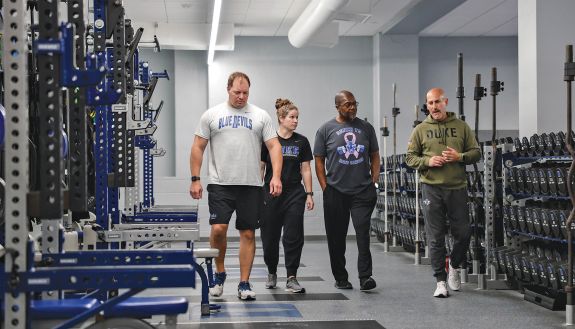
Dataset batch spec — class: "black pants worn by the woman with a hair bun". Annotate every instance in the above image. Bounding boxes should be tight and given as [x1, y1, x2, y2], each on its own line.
[260, 184, 307, 278]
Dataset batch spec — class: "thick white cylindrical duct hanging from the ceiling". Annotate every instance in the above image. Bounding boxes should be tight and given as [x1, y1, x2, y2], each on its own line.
[288, 0, 349, 48]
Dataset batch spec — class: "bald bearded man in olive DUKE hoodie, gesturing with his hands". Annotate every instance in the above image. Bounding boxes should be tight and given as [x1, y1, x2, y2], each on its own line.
[406, 88, 481, 297]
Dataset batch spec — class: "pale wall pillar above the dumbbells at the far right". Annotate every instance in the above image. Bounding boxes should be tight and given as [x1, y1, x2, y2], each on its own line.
[518, 0, 575, 136]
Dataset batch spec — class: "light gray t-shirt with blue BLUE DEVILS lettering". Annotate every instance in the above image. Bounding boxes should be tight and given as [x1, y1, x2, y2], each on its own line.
[195, 102, 277, 186]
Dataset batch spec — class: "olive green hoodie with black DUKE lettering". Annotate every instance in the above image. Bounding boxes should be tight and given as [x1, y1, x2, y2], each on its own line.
[406, 112, 481, 189]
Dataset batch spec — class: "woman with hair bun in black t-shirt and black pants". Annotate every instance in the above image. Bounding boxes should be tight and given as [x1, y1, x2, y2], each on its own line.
[261, 98, 314, 293]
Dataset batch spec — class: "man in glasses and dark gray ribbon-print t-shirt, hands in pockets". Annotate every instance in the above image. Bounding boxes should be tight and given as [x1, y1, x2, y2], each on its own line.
[313, 90, 380, 291]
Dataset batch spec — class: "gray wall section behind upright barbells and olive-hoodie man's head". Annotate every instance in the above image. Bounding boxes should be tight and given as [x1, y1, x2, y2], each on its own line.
[419, 37, 519, 137]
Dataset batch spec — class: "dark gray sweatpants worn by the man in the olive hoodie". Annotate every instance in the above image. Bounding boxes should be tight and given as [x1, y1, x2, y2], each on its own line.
[421, 184, 471, 282]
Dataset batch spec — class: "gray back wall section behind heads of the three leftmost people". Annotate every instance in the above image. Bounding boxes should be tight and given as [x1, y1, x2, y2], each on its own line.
[209, 37, 373, 145]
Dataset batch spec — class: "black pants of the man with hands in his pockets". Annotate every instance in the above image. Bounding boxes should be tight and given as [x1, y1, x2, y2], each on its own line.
[323, 185, 377, 281]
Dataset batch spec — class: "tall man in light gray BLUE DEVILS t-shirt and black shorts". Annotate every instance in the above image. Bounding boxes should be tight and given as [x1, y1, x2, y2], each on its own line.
[190, 72, 282, 300]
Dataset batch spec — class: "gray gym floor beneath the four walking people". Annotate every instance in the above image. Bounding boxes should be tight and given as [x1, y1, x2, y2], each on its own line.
[145, 239, 565, 329]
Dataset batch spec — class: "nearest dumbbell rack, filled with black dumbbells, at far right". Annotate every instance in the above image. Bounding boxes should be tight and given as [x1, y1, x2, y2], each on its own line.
[500, 132, 571, 310]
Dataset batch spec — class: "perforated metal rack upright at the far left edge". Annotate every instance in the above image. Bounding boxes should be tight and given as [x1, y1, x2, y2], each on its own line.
[2, 0, 29, 329]
